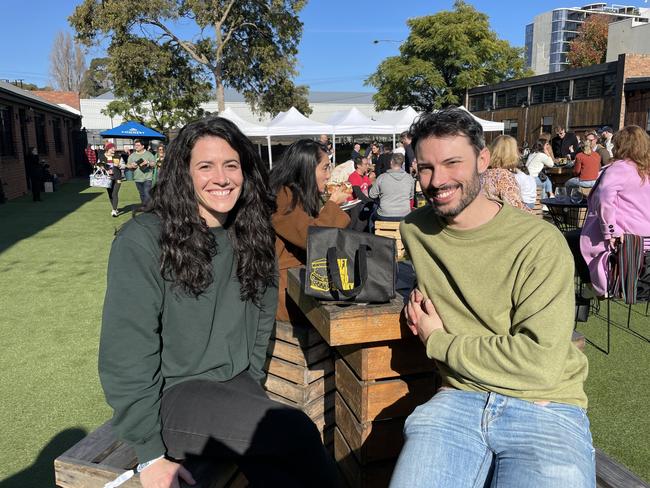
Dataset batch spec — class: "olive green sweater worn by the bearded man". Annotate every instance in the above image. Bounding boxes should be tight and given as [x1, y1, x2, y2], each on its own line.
[400, 205, 587, 408]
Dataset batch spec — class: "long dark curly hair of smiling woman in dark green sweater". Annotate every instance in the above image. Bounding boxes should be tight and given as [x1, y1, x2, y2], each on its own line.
[143, 117, 276, 303]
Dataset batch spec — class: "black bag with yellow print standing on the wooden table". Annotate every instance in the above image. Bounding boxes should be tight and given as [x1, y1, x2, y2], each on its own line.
[304, 226, 396, 303]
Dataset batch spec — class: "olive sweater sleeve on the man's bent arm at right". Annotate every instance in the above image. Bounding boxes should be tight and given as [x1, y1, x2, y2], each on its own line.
[426, 235, 574, 391]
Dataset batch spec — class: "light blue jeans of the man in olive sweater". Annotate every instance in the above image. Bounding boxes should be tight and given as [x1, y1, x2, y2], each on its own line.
[390, 389, 596, 488]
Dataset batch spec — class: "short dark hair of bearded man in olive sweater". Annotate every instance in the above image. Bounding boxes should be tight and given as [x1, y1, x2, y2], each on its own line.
[409, 107, 485, 156]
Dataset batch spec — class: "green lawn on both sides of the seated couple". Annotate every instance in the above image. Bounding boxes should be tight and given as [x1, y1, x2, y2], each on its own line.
[0, 181, 650, 488]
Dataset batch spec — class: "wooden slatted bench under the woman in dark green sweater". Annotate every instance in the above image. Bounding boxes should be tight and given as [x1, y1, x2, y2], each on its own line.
[54, 421, 247, 488]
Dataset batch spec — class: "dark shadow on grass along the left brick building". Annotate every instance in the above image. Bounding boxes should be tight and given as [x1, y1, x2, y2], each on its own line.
[0, 180, 100, 254]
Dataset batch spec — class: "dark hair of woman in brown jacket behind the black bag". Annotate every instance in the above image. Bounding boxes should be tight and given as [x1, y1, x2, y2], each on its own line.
[270, 139, 327, 217]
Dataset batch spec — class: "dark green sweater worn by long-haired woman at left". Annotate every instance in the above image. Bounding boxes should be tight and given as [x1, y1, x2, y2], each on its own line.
[99, 214, 278, 462]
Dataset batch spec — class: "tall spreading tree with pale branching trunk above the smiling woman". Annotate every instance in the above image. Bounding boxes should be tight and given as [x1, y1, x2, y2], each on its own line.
[69, 0, 306, 114]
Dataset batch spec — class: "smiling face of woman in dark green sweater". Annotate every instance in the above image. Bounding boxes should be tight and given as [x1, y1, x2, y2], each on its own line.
[190, 136, 244, 227]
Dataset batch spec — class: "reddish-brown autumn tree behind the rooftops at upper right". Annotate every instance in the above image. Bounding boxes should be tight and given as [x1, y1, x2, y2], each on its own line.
[566, 14, 609, 68]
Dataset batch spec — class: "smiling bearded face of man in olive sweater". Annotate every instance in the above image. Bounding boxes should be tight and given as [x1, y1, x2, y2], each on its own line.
[416, 135, 490, 219]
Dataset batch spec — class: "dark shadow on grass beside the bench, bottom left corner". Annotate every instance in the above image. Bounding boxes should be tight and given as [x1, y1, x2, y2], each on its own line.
[0, 428, 87, 488]
